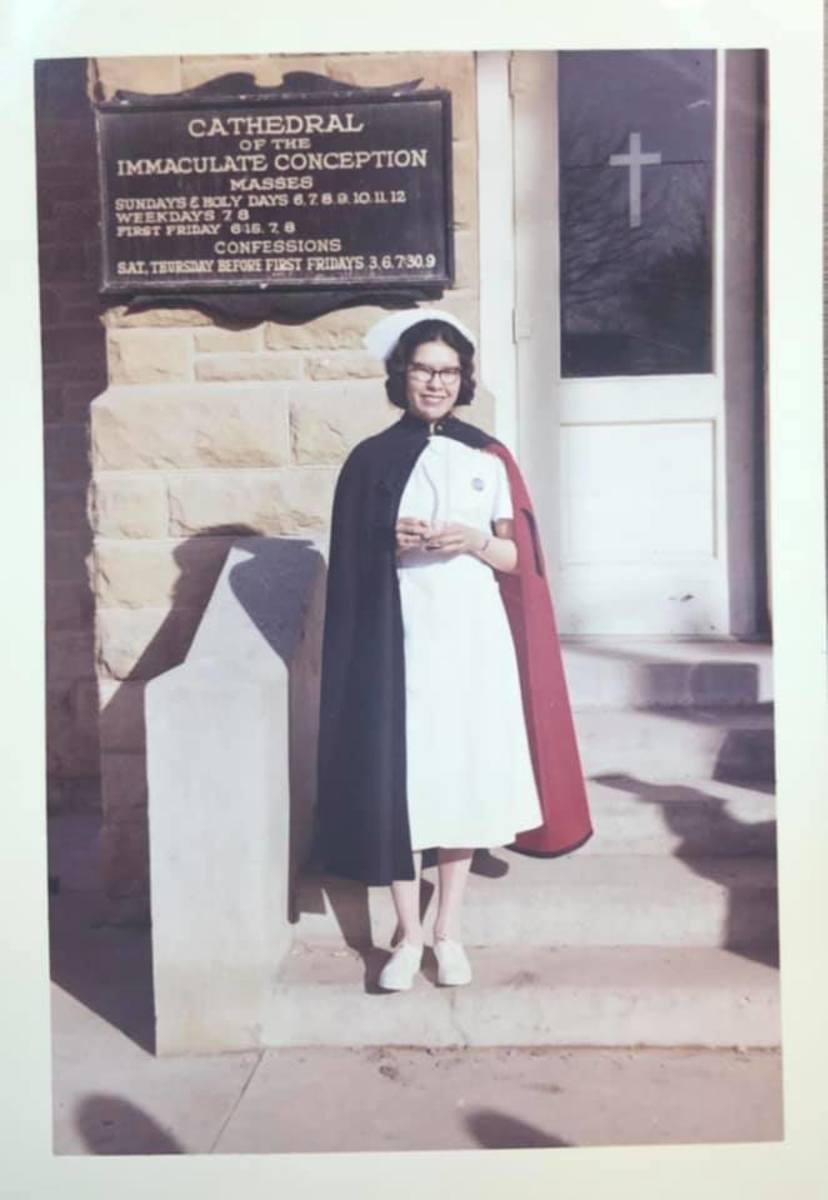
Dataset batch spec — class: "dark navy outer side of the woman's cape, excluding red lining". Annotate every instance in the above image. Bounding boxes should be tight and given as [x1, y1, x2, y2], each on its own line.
[317, 413, 589, 884]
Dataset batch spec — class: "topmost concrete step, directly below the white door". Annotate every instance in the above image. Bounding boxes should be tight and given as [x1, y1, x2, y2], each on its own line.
[562, 637, 773, 708]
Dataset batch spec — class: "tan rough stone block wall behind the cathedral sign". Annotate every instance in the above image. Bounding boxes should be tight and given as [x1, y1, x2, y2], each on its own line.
[88, 53, 484, 920]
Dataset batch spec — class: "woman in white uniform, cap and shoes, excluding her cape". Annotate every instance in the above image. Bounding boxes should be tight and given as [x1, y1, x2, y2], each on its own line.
[366, 310, 542, 991]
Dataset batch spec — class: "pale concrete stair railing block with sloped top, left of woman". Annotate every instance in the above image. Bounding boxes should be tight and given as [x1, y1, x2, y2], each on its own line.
[146, 538, 325, 1054]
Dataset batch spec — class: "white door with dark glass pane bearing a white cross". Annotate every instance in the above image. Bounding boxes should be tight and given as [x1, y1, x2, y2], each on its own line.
[494, 52, 761, 637]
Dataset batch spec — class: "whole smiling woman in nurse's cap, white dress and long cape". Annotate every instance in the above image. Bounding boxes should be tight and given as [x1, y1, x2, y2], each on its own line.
[319, 310, 592, 990]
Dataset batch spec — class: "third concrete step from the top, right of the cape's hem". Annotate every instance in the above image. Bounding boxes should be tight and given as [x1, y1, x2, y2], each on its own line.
[578, 775, 776, 858]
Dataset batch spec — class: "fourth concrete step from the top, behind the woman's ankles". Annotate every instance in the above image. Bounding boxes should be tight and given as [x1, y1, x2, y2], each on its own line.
[296, 851, 778, 949]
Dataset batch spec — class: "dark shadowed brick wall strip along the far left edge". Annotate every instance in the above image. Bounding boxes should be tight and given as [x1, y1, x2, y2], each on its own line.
[38, 59, 107, 812]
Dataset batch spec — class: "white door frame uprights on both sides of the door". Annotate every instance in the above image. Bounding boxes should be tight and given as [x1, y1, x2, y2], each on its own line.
[476, 50, 766, 637]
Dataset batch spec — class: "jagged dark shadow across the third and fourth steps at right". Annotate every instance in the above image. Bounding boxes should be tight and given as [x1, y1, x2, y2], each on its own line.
[593, 774, 779, 966]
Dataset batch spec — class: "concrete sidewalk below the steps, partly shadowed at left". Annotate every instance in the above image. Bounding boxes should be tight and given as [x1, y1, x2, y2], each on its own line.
[50, 818, 782, 1154]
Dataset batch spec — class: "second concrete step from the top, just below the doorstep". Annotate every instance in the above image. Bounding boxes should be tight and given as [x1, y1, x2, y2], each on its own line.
[574, 706, 774, 784]
